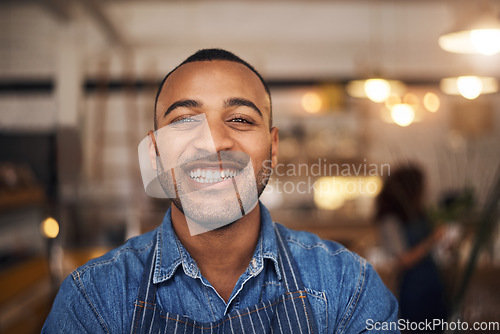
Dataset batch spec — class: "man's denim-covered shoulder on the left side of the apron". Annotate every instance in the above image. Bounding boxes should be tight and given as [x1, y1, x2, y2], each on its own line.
[46, 230, 156, 333]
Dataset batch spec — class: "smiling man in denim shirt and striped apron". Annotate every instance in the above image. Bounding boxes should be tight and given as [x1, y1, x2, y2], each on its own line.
[43, 49, 397, 333]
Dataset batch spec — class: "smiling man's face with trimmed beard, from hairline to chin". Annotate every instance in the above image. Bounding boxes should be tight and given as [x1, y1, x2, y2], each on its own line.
[156, 61, 278, 232]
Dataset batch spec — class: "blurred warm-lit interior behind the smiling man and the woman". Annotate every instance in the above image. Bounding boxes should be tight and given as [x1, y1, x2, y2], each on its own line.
[0, 0, 500, 333]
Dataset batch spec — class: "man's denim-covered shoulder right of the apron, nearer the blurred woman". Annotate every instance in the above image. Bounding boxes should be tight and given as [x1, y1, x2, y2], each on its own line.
[277, 224, 397, 333]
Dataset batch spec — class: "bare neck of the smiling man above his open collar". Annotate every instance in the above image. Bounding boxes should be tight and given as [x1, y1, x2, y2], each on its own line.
[171, 205, 260, 302]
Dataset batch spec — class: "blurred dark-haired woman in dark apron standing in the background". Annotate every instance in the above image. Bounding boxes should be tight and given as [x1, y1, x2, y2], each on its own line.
[375, 165, 447, 328]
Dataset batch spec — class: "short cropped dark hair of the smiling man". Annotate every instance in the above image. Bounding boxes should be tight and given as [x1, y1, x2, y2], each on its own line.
[153, 49, 273, 130]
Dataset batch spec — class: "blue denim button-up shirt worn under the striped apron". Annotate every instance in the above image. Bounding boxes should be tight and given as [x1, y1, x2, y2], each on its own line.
[42, 204, 398, 333]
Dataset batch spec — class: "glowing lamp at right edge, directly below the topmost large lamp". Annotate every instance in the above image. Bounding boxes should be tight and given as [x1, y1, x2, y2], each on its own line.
[440, 75, 498, 100]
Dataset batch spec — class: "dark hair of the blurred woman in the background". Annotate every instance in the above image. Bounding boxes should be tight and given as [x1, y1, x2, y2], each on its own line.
[375, 165, 424, 223]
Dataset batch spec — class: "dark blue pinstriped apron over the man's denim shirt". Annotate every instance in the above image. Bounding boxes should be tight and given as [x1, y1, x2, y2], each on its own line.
[130, 225, 318, 334]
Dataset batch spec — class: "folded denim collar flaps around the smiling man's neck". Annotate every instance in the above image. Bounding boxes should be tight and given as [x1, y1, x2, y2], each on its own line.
[153, 202, 281, 284]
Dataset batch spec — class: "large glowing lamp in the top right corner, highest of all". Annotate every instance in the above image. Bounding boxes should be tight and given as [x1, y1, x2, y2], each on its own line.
[439, 9, 500, 55]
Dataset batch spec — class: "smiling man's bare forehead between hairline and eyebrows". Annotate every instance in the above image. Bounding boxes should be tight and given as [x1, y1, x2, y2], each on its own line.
[158, 60, 270, 110]
